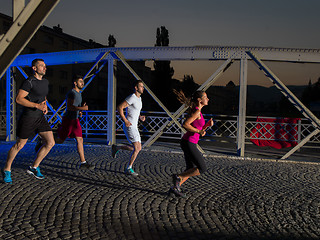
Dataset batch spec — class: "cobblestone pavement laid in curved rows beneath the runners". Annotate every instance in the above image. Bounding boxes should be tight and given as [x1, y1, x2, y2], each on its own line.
[0, 143, 320, 240]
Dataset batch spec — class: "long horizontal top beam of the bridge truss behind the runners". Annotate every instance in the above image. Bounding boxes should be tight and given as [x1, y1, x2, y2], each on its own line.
[12, 47, 320, 67]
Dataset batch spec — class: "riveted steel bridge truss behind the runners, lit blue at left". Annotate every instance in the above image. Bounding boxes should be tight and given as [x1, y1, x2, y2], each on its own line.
[7, 47, 320, 159]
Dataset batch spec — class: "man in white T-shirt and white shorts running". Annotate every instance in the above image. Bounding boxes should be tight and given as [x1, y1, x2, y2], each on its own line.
[112, 80, 145, 176]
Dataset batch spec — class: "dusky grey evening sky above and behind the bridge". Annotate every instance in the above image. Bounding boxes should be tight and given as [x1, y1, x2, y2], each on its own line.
[0, 0, 320, 85]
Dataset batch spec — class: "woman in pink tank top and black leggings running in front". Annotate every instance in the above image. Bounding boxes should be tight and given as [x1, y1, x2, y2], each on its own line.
[169, 91, 213, 197]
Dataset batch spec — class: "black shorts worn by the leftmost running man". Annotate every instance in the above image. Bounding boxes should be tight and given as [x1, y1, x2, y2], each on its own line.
[17, 115, 52, 139]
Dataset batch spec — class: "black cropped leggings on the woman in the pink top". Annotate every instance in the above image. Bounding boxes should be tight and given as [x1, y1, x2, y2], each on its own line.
[180, 139, 207, 173]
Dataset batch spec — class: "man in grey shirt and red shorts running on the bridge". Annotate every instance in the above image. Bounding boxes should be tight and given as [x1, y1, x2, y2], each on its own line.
[55, 75, 94, 170]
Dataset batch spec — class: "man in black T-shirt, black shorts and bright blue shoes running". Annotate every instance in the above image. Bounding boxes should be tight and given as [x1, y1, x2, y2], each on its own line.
[2, 59, 55, 183]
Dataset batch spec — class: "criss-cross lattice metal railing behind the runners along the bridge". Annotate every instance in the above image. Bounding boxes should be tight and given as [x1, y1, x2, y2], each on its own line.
[0, 111, 320, 145]
